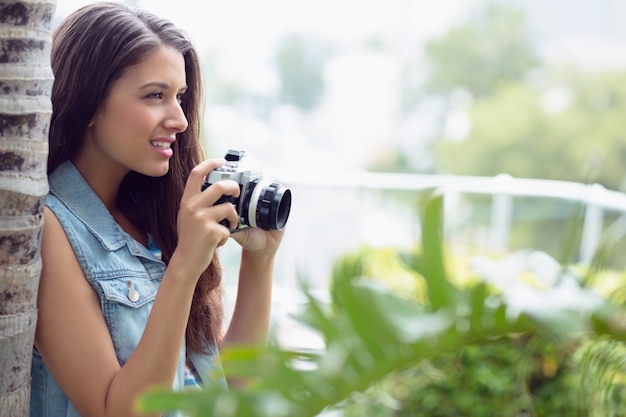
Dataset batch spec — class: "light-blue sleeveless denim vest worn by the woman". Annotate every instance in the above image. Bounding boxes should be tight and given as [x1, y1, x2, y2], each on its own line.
[30, 161, 226, 417]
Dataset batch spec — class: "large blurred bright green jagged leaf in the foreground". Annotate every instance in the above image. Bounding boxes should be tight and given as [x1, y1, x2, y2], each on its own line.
[137, 197, 625, 417]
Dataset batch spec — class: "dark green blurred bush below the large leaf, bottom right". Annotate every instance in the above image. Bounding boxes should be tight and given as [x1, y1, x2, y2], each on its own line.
[344, 336, 587, 417]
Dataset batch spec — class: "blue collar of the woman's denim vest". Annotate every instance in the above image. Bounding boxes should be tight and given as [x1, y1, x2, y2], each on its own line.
[48, 161, 130, 251]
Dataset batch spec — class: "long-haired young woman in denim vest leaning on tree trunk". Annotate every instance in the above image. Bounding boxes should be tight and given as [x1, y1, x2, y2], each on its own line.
[31, 3, 283, 417]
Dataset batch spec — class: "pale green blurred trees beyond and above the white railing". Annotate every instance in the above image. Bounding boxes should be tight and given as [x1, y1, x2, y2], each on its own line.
[394, 0, 626, 190]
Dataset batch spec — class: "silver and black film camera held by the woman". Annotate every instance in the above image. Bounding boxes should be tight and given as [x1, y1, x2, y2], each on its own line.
[202, 149, 291, 232]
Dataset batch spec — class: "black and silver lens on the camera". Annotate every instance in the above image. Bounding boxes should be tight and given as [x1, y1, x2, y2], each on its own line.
[242, 180, 291, 230]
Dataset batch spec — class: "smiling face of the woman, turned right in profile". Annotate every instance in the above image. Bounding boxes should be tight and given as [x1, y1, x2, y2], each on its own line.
[75, 47, 187, 177]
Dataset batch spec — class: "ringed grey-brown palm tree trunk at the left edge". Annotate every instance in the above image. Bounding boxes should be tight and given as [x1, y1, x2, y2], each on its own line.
[0, 0, 56, 417]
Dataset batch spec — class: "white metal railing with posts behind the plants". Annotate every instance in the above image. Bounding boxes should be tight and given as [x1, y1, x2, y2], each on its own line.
[284, 172, 626, 262]
